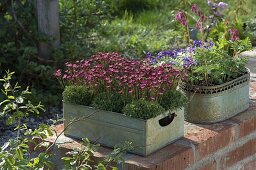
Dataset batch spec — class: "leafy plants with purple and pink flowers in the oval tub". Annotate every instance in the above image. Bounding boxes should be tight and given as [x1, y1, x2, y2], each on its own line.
[151, 0, 252, 86]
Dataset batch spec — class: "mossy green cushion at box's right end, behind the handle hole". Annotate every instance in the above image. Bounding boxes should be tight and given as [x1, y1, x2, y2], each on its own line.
[158, 90, 187, 110]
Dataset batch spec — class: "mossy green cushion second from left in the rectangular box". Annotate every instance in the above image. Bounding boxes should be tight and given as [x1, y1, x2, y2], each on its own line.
[92, 92, 125, 113]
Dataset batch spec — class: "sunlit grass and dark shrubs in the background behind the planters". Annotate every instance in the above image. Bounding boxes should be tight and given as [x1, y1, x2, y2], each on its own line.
[0, 0, 256, 111]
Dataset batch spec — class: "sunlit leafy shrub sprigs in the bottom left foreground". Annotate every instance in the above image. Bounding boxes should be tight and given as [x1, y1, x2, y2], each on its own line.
[0, 73, 133, 170]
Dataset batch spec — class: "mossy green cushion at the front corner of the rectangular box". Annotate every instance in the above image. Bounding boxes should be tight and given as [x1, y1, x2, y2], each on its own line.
[123, 99, 165, 120]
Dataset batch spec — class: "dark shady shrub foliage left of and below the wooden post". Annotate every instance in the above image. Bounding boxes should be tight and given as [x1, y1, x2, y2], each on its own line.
[0, 0, 63, 105]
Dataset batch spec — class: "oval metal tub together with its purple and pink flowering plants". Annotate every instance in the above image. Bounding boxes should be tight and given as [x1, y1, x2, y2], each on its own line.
[147, 0, 252, 123]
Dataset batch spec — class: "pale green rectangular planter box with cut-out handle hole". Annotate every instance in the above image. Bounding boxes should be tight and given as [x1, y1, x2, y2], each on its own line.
[63, 103, 184, 156]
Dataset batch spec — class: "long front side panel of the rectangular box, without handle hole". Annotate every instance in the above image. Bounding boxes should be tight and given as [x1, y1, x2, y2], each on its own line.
[63, 103, 146, 155]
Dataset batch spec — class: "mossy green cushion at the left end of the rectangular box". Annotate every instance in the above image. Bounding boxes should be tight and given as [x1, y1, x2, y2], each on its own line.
[63, 85, 93, 106]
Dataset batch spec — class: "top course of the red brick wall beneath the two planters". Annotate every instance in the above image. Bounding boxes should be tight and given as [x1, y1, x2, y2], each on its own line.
[48, 82, 256, 168]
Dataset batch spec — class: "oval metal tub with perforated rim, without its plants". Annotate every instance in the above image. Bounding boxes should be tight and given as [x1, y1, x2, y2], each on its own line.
[182, 71, 250, 124]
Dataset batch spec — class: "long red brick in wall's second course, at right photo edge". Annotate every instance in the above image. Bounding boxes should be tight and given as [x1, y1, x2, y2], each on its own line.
[221, 139, 256, 168]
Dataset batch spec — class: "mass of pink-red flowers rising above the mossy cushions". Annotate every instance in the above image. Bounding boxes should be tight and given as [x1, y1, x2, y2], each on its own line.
[55, 53, 185, 100]
